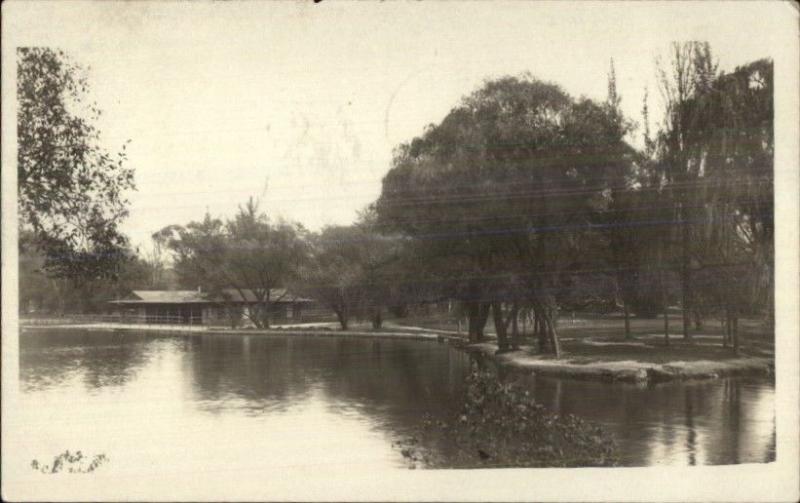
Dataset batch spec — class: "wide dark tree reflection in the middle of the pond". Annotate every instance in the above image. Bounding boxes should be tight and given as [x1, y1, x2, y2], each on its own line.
[184, 336, 468, 426]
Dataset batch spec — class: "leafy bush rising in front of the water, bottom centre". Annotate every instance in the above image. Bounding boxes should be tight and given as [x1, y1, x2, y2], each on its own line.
[400, 371, 616, 468]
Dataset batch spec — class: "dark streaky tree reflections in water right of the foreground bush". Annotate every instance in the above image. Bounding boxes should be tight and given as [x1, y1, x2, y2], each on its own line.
[510, 376, 774, 465]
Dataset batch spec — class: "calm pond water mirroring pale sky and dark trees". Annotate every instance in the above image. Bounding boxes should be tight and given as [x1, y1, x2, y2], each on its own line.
[14, 331, 775, 477]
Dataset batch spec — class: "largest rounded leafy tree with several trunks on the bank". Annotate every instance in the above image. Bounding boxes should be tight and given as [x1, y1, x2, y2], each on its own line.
[377, 76, 631, 354]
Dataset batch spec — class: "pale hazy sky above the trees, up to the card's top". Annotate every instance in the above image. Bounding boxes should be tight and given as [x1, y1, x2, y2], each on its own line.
[6, 1, 789, 252]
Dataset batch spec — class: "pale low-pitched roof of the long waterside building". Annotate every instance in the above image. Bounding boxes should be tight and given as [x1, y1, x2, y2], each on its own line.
[111, 288, 311, 304]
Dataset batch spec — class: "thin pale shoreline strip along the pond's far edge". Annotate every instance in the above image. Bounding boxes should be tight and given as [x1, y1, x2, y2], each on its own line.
[20, 324, 775, 384]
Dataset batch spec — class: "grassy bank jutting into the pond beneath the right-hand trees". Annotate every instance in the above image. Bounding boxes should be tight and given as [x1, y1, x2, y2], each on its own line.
[456, 316, 774, 382]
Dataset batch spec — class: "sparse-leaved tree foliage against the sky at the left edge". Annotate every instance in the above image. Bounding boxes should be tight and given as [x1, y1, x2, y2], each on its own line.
[17, 47, 134, 281]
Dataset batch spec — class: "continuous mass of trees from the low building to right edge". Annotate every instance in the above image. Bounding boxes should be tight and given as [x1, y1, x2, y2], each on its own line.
[17, 42, 774, 355]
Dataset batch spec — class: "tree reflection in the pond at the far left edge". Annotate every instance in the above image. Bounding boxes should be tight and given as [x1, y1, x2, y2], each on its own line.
[19, 330, 152, 391]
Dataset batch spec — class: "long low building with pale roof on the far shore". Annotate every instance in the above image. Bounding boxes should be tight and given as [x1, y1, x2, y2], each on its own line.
[110, 288, 314, 325]
